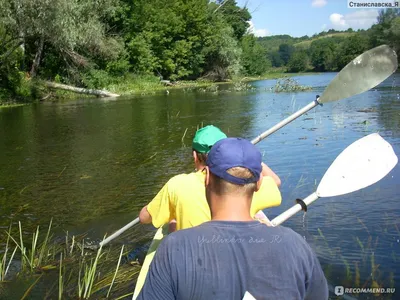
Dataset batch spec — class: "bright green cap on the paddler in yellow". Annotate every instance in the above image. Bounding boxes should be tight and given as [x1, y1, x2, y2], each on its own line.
[192, 125, 227, 153]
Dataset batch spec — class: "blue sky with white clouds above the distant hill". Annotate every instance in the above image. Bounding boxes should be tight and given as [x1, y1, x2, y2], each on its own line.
[236, 0, 391, 37]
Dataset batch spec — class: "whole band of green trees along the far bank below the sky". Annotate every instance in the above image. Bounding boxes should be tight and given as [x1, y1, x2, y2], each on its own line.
[0, 0, 400, 101]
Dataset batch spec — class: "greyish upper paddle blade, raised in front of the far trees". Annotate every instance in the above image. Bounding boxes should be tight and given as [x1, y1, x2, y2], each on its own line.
[318, 45, 398, 103]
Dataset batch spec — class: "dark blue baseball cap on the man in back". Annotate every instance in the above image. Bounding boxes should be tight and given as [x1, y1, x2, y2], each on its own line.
[206, 138, 262, 185]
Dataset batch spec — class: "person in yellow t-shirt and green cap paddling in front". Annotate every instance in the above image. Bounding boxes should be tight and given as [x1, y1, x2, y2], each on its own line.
[139, 125, 282, 231]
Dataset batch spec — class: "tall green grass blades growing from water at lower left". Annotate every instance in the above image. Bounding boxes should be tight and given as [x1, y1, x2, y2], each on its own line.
[0, 219, 147, 299]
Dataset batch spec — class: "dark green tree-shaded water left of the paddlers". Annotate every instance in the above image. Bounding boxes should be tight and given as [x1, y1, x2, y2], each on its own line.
[0, 92, 254, 232]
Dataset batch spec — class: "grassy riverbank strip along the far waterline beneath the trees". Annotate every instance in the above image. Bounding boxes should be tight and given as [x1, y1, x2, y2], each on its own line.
[0, 70, 317, 108]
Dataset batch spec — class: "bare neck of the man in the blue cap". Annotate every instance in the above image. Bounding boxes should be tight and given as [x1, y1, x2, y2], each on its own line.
[210, 196, 254, 222]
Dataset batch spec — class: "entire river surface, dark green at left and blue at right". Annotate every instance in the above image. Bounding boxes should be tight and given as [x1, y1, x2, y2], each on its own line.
[0, 73, 400, 299]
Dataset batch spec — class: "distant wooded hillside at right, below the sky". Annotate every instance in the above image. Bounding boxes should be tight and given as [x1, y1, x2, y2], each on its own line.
[259, 9, 400, 72]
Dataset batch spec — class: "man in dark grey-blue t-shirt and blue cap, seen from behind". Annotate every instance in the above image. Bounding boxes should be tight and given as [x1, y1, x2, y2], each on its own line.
[138, 138, 328, 300]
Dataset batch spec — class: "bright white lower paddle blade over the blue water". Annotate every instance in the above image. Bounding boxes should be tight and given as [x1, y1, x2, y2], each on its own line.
[317, 133, 398, 197]
